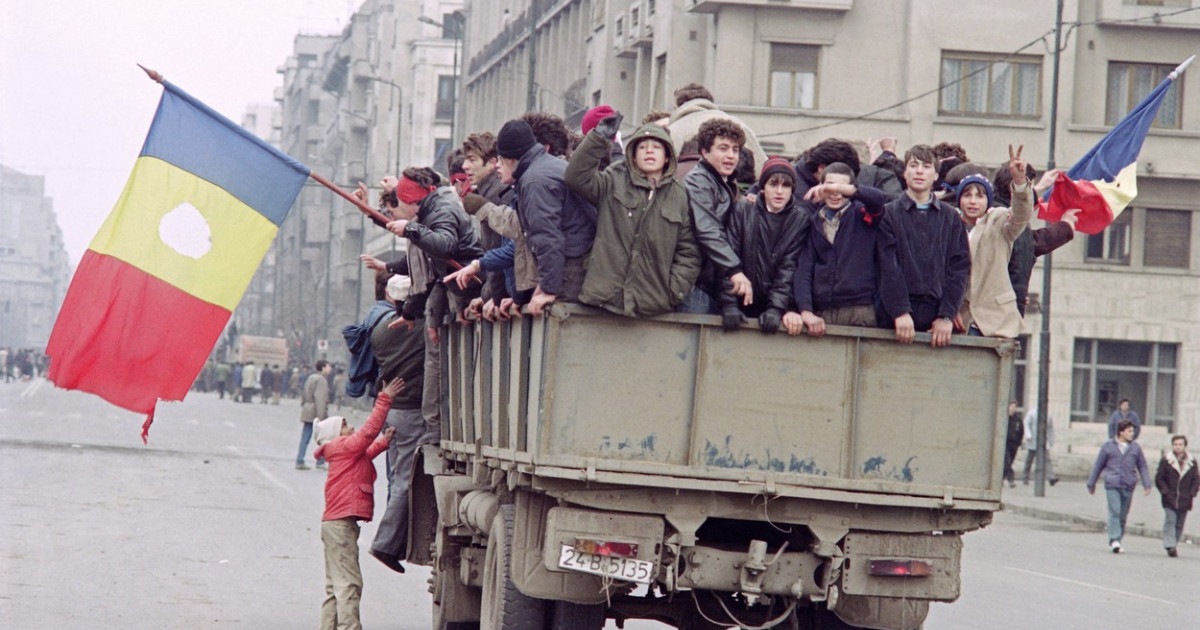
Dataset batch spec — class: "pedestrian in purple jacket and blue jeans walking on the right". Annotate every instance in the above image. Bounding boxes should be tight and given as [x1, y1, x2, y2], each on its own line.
[1087, 420, 1150, 553]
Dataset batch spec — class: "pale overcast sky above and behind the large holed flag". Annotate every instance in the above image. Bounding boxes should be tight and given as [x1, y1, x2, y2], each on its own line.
[0, 0, 359, 264]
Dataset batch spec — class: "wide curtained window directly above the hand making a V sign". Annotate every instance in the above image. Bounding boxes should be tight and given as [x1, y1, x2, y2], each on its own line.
[938, 53, 1042, 118]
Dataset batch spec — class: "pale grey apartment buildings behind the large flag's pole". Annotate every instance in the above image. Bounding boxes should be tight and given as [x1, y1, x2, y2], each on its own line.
[232, 0, 462, 362]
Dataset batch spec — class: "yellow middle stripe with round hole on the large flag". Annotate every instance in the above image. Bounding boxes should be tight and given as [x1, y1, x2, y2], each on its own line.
[89, 157, 278, 311]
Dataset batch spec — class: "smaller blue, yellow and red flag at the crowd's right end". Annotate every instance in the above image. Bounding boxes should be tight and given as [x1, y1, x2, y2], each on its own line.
[1038, 59, 1192, 235]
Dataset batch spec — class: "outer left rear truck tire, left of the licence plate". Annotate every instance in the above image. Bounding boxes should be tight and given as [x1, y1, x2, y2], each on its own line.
[479, 504, 546, 630]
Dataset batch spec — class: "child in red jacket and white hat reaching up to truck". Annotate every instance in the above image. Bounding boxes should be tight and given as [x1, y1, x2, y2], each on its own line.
[314, 378, 404, 630]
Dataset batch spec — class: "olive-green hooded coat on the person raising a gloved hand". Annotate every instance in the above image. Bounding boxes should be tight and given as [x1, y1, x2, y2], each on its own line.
[565, 124, 701, 317]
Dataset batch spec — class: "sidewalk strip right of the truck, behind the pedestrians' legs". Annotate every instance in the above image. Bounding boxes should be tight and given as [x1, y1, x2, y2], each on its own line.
[1002, 472, 1200, 545]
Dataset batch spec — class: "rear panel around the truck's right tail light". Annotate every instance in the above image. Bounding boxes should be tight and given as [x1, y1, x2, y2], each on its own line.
[841, 532, 962, 601]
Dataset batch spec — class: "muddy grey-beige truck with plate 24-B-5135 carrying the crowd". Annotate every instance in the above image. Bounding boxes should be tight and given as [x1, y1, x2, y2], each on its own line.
[408, 305, 1016, 630]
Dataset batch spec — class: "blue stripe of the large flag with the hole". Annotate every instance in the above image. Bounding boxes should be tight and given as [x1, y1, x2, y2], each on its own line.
[142, 82, 308, 226]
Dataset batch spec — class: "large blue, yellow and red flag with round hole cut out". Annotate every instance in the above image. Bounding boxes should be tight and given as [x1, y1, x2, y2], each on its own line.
[46, 80, 308, 440]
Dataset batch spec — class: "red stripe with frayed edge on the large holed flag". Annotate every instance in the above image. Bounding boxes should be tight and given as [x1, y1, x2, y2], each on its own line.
[46, 250, 230, 414]
